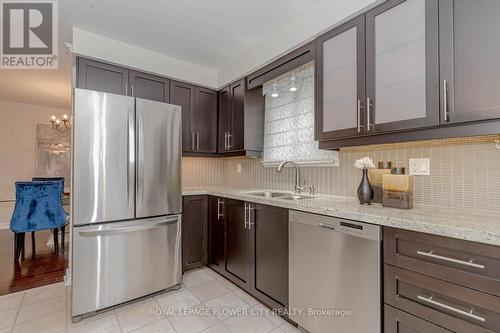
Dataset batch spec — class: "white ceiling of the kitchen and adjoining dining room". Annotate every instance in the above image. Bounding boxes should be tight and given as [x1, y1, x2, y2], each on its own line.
[0, 0, 322, 108]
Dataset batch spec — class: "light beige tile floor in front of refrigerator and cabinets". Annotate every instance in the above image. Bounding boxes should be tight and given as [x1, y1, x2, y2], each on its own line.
[0, 268, 299, 333]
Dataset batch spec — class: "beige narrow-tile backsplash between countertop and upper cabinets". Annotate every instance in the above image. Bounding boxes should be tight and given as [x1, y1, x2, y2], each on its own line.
[183, 136, 500, 211]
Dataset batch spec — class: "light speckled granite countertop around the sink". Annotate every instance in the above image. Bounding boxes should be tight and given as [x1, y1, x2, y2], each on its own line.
[182, 186, 500, 246]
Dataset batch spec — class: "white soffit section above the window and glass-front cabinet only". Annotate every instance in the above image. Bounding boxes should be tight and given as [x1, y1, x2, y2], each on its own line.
[218, 0, 381, 87]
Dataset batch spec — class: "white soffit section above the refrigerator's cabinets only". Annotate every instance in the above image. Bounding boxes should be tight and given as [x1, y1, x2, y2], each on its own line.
[73, 27, 218, 88]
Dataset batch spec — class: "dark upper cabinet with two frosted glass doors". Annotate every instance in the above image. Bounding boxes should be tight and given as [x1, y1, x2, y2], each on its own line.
[316, 0, 439, 141]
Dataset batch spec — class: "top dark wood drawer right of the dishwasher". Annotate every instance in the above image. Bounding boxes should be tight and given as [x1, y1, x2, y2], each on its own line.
[384, 228, 500, 296]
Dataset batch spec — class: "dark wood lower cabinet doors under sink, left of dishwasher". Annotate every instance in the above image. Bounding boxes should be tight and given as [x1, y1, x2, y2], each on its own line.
[208, 197, 288, 309]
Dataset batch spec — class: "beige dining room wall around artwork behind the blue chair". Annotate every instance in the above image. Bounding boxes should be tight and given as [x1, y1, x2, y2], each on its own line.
[0, 101, 70, 200]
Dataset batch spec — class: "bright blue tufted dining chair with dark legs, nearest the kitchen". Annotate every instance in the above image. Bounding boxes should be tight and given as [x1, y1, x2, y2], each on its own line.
[10, 181, 66, 261]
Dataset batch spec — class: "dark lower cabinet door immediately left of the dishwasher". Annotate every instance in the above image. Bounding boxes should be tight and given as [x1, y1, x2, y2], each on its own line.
[249, 204, 288, 308]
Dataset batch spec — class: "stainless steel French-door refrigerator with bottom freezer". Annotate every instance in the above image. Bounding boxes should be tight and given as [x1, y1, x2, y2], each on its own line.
[72, 89, 182, 321]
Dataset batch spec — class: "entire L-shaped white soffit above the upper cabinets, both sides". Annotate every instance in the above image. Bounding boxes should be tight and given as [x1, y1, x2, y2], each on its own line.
[73, 0, 383, 88]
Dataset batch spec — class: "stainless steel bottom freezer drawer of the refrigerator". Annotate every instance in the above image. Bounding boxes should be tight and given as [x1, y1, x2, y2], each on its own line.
[72, 215, 182, 317]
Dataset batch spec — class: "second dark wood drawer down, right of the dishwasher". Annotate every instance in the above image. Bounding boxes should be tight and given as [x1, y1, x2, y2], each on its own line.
[384, 264, 500, 333]
